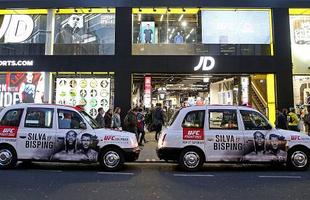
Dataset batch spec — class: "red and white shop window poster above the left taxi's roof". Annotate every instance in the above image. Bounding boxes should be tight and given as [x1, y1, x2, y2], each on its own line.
[0, 72, 44, 107]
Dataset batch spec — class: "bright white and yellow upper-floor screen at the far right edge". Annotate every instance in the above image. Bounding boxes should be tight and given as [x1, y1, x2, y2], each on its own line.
[290, 15, 310, 74]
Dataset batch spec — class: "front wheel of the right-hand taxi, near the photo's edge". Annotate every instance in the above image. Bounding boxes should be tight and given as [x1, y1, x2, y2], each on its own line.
[287, 148, 310, 171]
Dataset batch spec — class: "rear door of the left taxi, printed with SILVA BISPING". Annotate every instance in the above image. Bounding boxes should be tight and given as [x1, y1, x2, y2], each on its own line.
[17, 107, 56, 160]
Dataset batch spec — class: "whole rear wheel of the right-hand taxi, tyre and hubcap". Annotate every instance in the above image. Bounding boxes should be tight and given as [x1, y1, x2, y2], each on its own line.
[179, 148, 204, 171]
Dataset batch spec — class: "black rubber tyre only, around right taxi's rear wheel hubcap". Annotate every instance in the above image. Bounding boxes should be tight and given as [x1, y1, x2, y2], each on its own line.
[179, 147, 204, 172]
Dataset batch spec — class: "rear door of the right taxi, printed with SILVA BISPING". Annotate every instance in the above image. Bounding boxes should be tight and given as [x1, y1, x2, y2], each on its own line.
[205, 109, 244, 162]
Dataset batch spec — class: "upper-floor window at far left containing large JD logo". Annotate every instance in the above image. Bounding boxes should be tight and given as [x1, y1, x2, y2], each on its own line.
[0, 9, 47, 55]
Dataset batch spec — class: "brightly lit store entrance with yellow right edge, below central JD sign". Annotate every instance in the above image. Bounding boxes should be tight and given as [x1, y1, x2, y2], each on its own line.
[132, 73, 275, 122]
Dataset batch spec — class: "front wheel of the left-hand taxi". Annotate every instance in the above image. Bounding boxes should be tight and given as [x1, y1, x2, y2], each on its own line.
[99, 147, 125, 172]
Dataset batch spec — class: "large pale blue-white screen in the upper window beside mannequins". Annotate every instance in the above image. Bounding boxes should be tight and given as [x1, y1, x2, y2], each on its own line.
[201, 10, 271, 44]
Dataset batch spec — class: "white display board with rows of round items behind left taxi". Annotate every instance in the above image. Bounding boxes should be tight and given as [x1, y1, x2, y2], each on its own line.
[56, 78, 110, 117]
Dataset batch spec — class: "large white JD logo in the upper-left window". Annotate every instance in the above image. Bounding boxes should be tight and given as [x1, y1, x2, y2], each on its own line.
[0, 15, 33, 43]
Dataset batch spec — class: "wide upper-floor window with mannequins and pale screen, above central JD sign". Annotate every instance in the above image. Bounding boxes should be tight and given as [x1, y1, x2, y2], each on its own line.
[132, 8, 273, 55]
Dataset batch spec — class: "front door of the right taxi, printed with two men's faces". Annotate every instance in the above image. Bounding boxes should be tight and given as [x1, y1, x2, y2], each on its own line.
[240, 110, 287, 162]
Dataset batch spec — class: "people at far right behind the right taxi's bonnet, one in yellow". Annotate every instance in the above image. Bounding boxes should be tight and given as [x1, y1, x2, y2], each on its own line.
[275, 106, 310, 136]
